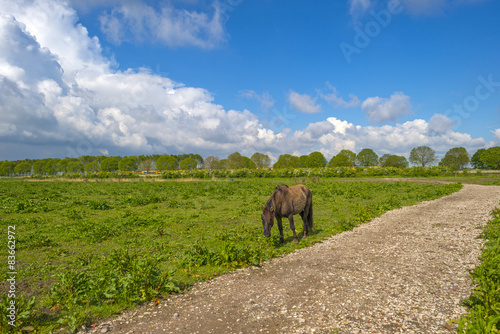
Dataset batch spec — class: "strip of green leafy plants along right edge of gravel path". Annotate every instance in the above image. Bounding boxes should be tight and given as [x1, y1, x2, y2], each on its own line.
[458, 206, 500, 333]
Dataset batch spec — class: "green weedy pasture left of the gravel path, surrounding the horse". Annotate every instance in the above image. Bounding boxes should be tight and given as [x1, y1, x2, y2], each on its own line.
[0, 178, 461, 333]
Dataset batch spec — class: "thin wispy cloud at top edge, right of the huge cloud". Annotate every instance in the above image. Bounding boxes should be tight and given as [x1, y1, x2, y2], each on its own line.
[100, 1, 227, 48]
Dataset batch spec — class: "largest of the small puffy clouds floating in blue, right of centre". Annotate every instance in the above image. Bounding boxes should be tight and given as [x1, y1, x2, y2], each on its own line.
[361, 92, 411, 124]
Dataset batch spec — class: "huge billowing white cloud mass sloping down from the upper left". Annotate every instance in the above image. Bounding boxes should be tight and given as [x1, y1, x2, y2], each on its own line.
[0, 1, 280, 156]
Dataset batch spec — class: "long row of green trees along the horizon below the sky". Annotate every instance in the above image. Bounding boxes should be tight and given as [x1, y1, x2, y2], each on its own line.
[0, 146, 500, 176]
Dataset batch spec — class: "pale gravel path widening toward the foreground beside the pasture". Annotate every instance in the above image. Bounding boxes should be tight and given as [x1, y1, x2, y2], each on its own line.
[84, 185, 500, 334]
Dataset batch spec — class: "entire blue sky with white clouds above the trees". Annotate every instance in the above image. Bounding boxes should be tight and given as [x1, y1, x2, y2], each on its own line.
[0, 0, 500, 160]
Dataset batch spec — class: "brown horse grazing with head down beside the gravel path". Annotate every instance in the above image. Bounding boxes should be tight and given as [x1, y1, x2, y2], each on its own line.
[261, 184, 314, 244]
